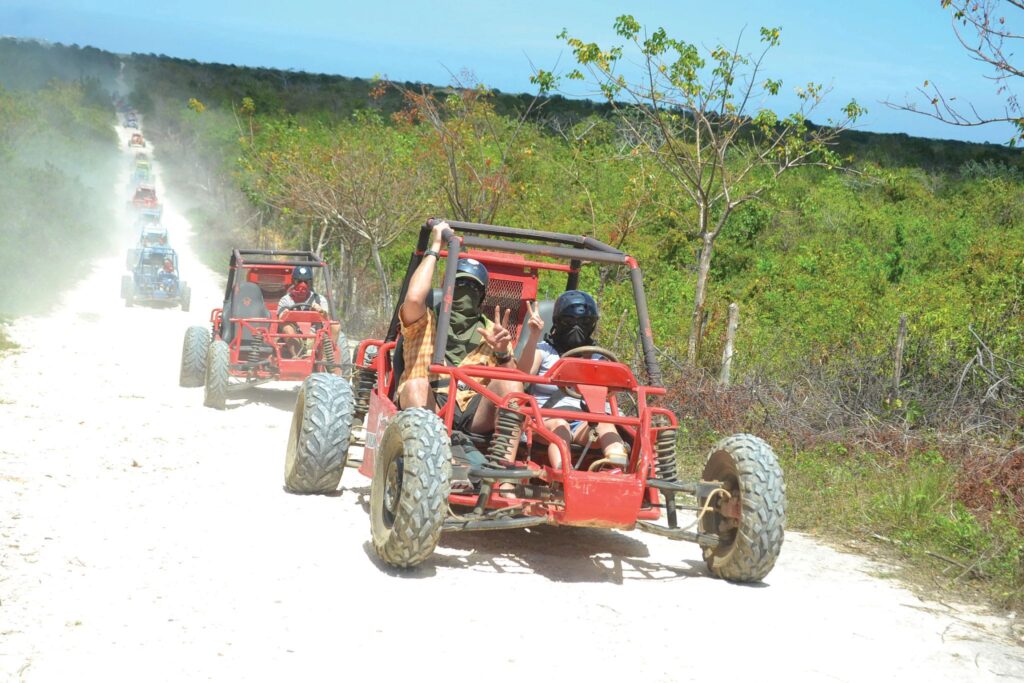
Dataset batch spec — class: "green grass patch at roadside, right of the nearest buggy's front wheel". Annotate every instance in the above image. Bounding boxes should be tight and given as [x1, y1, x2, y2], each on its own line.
[779, 444, 1024, 609]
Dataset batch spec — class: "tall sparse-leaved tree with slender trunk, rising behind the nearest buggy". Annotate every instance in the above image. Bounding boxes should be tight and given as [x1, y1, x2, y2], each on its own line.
[532, 15, 864, 365]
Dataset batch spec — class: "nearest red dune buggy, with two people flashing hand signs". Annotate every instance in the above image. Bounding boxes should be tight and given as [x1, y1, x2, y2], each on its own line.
[285, 221, 785, 582]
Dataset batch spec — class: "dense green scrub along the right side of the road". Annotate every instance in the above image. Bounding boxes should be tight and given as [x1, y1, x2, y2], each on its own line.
[4, 34, 1024, 604]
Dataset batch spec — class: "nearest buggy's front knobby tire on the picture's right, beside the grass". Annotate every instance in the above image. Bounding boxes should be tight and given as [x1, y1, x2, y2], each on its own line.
[699, 434, 785, 582]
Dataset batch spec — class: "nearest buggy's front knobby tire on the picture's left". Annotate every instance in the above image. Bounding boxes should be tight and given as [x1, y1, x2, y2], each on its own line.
[370, 408, 452, 568]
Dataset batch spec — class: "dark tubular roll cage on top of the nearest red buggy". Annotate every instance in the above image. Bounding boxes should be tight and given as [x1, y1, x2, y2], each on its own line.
[385, 218, 662, 387]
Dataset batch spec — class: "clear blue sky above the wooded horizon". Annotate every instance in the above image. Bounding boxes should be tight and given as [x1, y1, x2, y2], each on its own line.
[0, 0, 1024, 143]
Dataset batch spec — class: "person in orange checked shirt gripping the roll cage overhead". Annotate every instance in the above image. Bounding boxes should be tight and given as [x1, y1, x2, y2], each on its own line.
[398, 221, 522, 433]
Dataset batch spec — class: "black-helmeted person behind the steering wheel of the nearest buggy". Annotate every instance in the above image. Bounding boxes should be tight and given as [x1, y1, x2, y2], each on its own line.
[518, 290, 629, 469]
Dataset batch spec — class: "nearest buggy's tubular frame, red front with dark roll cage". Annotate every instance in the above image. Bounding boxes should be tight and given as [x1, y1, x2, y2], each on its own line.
[355, 221, 678, 528]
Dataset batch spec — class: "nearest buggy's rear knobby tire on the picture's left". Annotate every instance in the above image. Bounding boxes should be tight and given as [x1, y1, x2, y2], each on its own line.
[285, 373, 355, 494]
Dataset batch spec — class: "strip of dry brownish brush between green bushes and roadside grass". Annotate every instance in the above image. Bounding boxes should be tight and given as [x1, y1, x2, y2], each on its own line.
[647, 339, 1024, 529]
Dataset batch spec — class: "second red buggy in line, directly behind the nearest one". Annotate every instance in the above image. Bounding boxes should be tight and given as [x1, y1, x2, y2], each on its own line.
[179, 249, 344, 410]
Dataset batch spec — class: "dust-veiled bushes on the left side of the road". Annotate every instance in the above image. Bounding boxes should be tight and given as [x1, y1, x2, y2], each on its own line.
[0, 42, 117, 314]
